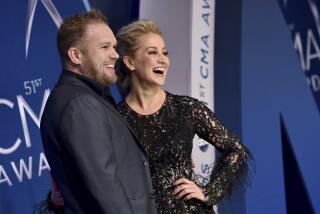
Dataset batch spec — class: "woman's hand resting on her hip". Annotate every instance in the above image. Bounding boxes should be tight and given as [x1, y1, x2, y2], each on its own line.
[173, 178, 208, 202]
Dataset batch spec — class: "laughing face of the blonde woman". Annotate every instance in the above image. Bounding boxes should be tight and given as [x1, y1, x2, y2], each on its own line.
[132, 33, 170, 86]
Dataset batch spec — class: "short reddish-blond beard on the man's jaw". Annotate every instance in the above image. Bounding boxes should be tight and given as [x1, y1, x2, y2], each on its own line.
[82, 59, 117, 85]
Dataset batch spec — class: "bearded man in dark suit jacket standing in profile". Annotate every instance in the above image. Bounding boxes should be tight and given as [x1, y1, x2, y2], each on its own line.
[41, 9, 156, 214]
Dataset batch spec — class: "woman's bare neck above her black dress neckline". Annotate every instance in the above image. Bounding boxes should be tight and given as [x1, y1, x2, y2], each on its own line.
[125, 85, 166, 115]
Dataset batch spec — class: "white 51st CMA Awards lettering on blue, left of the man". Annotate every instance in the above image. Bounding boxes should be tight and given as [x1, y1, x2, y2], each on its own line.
[0, 85, 50, 186]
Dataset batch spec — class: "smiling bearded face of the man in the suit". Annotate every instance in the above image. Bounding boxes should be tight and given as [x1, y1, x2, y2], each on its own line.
[80, 23, 119, 85]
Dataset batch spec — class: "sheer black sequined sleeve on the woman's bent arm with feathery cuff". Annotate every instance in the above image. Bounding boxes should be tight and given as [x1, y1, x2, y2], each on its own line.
[189, 99, 252, 205]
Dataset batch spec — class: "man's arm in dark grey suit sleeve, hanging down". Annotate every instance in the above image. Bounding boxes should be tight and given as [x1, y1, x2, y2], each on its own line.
[60, 95, 133, 214]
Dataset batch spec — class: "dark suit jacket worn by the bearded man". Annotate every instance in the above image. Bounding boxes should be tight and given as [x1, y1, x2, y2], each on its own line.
[40, 71, 156, 214]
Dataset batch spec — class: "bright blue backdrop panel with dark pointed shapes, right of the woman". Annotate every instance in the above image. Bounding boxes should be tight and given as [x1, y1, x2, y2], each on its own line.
[241, 0, 320, 214]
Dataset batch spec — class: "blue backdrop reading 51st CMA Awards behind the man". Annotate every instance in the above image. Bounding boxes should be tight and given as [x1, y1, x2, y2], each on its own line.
[0, 0, 139, 214]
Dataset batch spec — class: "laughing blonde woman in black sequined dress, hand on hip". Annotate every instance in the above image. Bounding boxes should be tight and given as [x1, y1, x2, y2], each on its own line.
[47, 20, 251, 213]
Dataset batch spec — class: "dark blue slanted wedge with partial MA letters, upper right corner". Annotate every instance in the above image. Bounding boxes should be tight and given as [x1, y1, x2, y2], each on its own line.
[278, 0, 320, 111]
